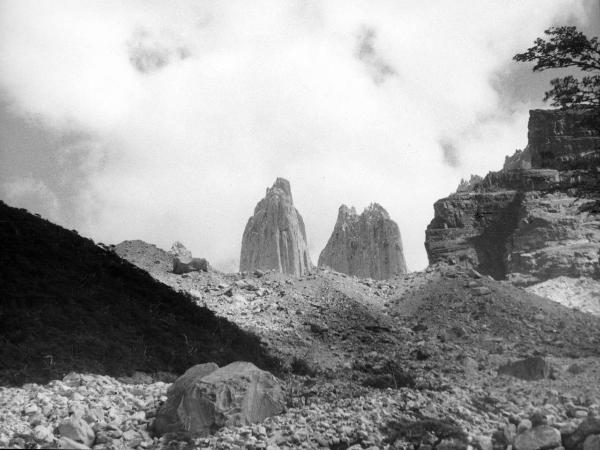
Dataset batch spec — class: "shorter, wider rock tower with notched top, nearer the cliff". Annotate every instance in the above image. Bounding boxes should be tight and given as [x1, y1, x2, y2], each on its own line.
[319, 203, 406, 279]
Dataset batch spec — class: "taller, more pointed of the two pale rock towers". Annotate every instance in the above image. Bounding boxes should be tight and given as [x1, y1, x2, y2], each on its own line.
[240, 178, 312, 276]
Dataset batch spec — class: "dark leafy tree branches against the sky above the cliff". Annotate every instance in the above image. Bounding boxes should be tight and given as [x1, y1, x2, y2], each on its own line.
[514, 27, 600, 109]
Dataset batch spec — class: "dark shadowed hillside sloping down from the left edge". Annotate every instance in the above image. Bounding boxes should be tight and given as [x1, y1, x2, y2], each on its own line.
[0, 201, 274, 384]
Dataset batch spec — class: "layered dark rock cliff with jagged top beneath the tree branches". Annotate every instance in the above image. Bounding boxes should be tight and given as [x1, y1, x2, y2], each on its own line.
[425, 110, 600, 285]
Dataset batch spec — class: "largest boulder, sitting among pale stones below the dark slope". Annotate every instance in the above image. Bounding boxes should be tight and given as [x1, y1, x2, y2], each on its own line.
[155, 362, 286, 436]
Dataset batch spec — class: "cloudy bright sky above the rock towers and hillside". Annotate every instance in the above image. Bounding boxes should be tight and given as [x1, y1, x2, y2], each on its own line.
[0, 0, 600, 271]
